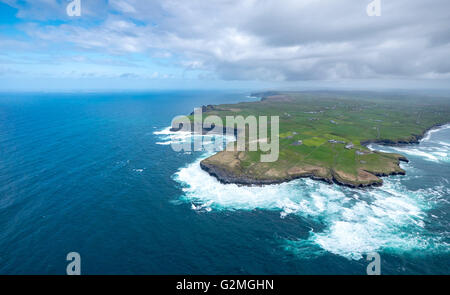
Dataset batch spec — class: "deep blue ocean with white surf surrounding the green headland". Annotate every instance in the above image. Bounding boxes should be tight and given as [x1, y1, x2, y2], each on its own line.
[0, 91, 450, 274]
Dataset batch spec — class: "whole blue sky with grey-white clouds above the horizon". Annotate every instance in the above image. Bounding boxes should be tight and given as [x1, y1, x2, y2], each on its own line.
[0, 0, 450, 91]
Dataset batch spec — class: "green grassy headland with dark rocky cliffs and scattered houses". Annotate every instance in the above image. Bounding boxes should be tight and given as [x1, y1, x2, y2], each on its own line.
[173, 91, 450, 188]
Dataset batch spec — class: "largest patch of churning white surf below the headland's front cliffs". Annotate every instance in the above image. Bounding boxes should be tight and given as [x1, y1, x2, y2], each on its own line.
[175, 154, 446, 259]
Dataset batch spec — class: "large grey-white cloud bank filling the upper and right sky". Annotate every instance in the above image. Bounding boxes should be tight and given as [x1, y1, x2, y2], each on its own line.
[0, 0, 450, 81]
